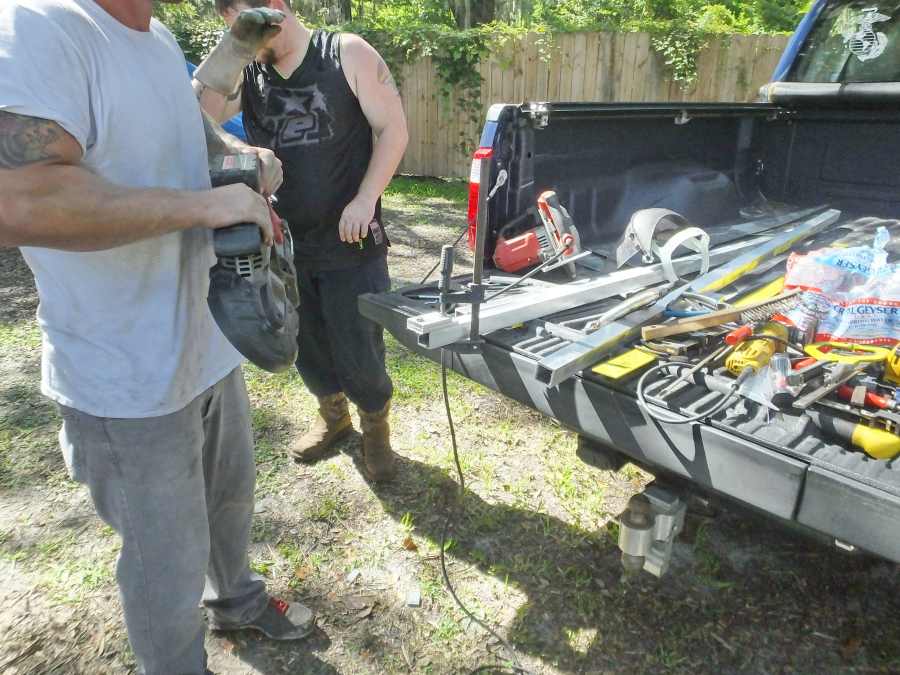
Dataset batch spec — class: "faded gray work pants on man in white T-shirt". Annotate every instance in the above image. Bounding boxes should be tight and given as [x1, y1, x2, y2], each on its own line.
[59, 368, 268, 675]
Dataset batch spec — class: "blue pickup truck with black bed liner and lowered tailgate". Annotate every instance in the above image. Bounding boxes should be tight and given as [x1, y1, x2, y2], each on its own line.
[359, 0, 900, 562]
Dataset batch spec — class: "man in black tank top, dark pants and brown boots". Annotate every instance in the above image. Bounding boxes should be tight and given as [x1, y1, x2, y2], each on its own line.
[195, 0, 407, 480]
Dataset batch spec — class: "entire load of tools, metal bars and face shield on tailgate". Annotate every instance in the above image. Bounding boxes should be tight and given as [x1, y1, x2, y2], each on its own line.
[420, 184, 900, 459]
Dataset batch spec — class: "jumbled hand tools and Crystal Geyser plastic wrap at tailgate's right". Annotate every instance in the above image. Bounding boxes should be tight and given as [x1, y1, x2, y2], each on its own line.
[628, 224, 900, 459]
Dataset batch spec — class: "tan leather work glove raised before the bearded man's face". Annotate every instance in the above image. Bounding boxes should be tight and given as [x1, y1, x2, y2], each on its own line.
[194, 7, 284, 97]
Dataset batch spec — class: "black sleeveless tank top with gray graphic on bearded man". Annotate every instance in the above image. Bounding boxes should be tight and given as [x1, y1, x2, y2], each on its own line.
[241, 30, 390, 270]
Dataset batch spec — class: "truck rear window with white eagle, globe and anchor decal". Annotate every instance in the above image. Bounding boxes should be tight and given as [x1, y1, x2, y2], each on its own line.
[788, 0, 900, 83]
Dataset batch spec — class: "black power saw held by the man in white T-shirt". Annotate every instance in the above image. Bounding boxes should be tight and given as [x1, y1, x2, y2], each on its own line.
[207, 154, 300, 372]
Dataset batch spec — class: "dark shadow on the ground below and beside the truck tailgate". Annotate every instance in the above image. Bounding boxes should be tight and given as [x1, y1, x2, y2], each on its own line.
[355, 456, 900, 673]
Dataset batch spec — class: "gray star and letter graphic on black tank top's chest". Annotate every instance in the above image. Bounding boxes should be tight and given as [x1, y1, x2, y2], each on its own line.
[257, 74, 334, 149]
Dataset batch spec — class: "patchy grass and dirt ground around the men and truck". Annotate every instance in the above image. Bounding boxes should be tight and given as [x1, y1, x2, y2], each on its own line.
[0, 185, 900, 675]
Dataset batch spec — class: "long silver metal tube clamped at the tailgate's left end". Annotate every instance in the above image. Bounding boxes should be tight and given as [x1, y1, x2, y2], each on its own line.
[406, 239, 772, 349]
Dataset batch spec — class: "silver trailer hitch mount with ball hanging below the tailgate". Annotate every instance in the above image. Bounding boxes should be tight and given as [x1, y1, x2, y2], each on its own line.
[619, 484, 687, 577]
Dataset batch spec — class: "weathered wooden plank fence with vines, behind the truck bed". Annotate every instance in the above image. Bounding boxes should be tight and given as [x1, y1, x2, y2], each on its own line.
[400, 33, 788, 178]
